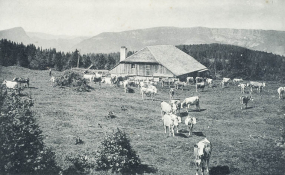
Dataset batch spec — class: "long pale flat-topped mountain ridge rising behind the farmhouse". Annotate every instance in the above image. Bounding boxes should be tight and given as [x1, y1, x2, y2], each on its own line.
[73, 27, 285, 55]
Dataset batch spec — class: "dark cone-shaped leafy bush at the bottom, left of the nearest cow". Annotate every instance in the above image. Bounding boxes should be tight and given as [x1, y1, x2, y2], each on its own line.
[96, 129, 141, 174]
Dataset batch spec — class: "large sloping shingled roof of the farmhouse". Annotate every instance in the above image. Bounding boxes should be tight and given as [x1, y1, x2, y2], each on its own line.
[118, 45, 207, 76]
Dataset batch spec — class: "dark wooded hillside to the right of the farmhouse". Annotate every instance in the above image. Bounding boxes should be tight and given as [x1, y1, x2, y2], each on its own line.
[177, 44, 285, 80]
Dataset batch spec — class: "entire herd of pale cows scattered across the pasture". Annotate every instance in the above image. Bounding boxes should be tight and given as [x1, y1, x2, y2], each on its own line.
[2, 74, 285, 174]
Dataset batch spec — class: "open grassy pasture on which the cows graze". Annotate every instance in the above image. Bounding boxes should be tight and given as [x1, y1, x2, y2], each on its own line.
[0, 66, 285, 175]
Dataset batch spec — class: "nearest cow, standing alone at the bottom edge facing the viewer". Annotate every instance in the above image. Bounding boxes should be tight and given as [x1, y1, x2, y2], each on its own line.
[194, 138, 212, 175]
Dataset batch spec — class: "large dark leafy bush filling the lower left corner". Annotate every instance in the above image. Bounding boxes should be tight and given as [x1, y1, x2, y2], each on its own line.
[0, 90, 60, 174]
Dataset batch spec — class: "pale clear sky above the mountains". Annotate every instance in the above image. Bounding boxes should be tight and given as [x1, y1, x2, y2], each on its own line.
[0, 0, 285, 36]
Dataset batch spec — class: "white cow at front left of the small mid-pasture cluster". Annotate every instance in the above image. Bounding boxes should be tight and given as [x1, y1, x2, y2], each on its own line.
[162, 114, 181, 137]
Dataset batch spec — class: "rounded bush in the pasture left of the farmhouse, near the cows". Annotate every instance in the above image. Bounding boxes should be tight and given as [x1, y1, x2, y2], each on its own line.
[55, 70, 91, 92]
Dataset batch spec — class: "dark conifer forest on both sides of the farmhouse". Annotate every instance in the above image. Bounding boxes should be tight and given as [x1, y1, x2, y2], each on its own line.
[0, 39, 285, 80]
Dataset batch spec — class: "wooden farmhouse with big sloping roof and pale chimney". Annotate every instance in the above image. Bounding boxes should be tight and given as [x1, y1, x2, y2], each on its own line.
[110, 45, 208, 80]
